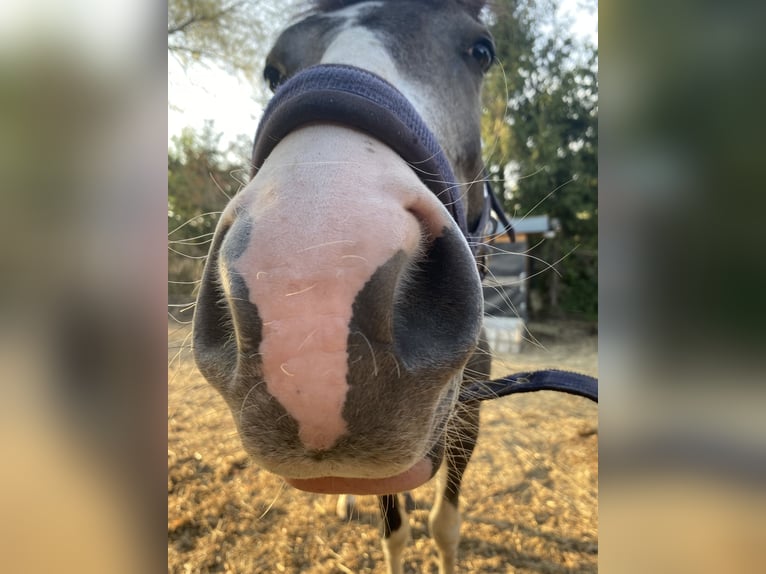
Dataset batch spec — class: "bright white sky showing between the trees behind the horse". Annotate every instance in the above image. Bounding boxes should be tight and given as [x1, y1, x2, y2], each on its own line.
[168, 0, 598, 151]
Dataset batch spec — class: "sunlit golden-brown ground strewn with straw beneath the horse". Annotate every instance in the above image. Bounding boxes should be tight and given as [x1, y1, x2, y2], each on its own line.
[168, 323, 598, 574]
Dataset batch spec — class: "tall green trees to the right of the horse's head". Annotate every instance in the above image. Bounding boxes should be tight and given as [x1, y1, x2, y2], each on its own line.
[482, 0, 598, 319]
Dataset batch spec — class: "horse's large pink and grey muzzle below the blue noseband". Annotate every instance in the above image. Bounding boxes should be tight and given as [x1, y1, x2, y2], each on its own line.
[194, 64, 482, 493]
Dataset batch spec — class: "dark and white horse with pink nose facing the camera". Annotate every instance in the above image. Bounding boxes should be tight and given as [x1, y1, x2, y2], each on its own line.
[193, 0, 524, 573]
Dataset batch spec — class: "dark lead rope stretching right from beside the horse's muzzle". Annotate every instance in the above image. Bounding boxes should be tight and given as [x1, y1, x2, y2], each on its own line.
[458, 369, 598, 403]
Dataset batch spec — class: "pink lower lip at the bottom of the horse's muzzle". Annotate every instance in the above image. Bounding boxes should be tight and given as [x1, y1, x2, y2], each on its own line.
[285, 458, 433, 495]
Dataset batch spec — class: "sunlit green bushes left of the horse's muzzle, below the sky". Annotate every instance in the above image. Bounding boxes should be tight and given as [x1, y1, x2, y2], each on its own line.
[168, 123, 248, 304]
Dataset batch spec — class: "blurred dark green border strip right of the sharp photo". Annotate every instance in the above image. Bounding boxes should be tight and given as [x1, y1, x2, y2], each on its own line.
[599, 1, 766, 572]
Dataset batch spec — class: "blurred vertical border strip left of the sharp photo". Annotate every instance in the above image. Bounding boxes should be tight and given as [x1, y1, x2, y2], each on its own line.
[0, 0, 167, 573]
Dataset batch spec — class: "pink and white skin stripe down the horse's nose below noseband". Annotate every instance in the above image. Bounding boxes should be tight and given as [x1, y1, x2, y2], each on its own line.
[232, 126, 451, 454]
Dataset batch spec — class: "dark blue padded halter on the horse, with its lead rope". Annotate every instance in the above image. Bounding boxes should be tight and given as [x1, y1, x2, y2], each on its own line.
[251, 64, 598, 403]
